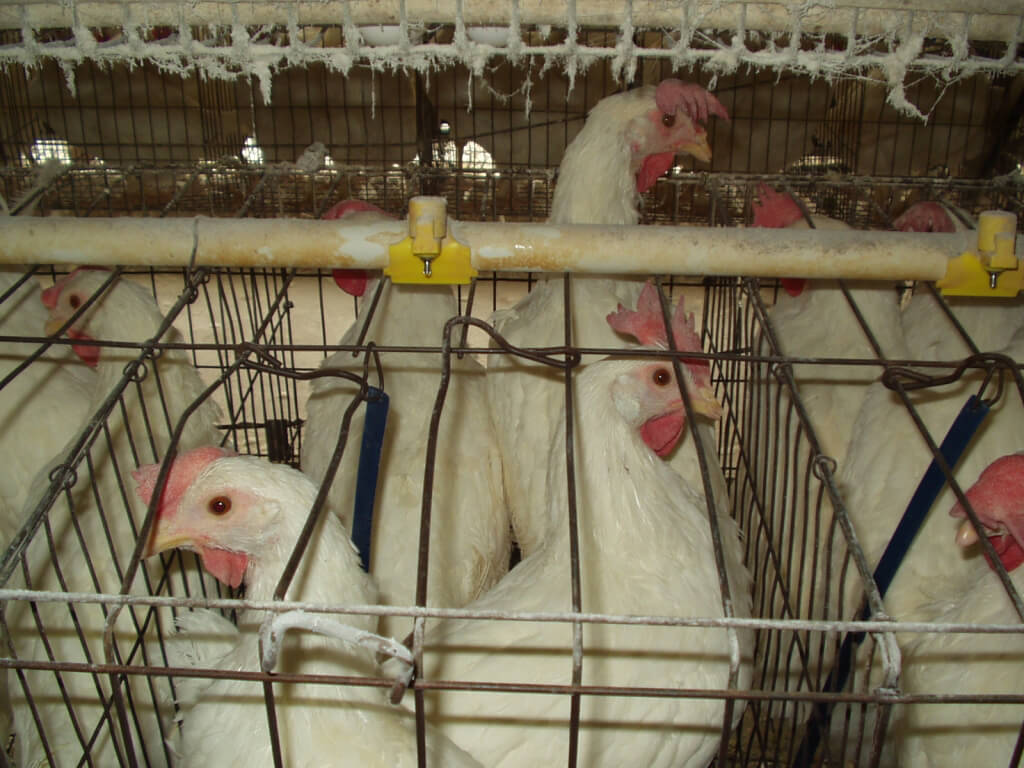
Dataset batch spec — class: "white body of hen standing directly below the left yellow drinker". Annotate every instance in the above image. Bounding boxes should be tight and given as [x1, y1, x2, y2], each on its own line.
[302, 274, 511, 637]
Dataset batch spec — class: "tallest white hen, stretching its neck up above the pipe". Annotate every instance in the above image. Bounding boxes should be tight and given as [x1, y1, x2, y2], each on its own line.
[487, 79, 727, 555]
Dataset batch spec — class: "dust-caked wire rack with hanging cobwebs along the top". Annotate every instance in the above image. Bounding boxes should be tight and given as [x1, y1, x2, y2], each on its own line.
[0, 0, 1024, 119]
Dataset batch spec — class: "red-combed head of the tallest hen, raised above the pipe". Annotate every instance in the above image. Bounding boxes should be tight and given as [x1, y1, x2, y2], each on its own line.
[630, 78, 729, 194]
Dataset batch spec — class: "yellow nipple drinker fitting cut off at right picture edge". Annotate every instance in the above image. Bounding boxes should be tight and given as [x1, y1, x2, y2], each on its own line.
[935, 211, 1024, 298]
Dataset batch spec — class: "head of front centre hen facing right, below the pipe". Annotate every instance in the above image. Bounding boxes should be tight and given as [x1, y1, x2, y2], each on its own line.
[607, 283, 722, 457]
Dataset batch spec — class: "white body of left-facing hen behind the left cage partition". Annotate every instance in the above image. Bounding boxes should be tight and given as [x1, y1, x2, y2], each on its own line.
[7, 270, 219, 767]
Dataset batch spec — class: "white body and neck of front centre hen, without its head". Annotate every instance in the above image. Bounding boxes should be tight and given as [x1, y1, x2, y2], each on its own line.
[413, 360, 753, 768]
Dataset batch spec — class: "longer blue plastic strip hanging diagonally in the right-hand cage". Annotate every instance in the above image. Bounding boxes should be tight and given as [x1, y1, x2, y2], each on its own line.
[793, 395, 989, 768]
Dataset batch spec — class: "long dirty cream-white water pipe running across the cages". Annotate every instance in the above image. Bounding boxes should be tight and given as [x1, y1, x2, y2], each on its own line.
[0, 216, 966, 281]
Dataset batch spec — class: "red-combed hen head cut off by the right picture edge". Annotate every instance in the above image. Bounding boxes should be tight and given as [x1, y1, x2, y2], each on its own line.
[949, 454, 1024, 571]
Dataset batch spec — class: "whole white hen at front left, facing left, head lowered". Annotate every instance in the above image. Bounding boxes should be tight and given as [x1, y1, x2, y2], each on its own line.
[136, 447, 476, 768]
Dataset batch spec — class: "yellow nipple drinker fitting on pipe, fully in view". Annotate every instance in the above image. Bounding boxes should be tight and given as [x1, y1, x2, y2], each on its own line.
[384, 196, 477, 286]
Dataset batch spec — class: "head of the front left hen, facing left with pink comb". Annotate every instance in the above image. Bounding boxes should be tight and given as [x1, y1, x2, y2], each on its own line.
[132, 446, 284, 587]
